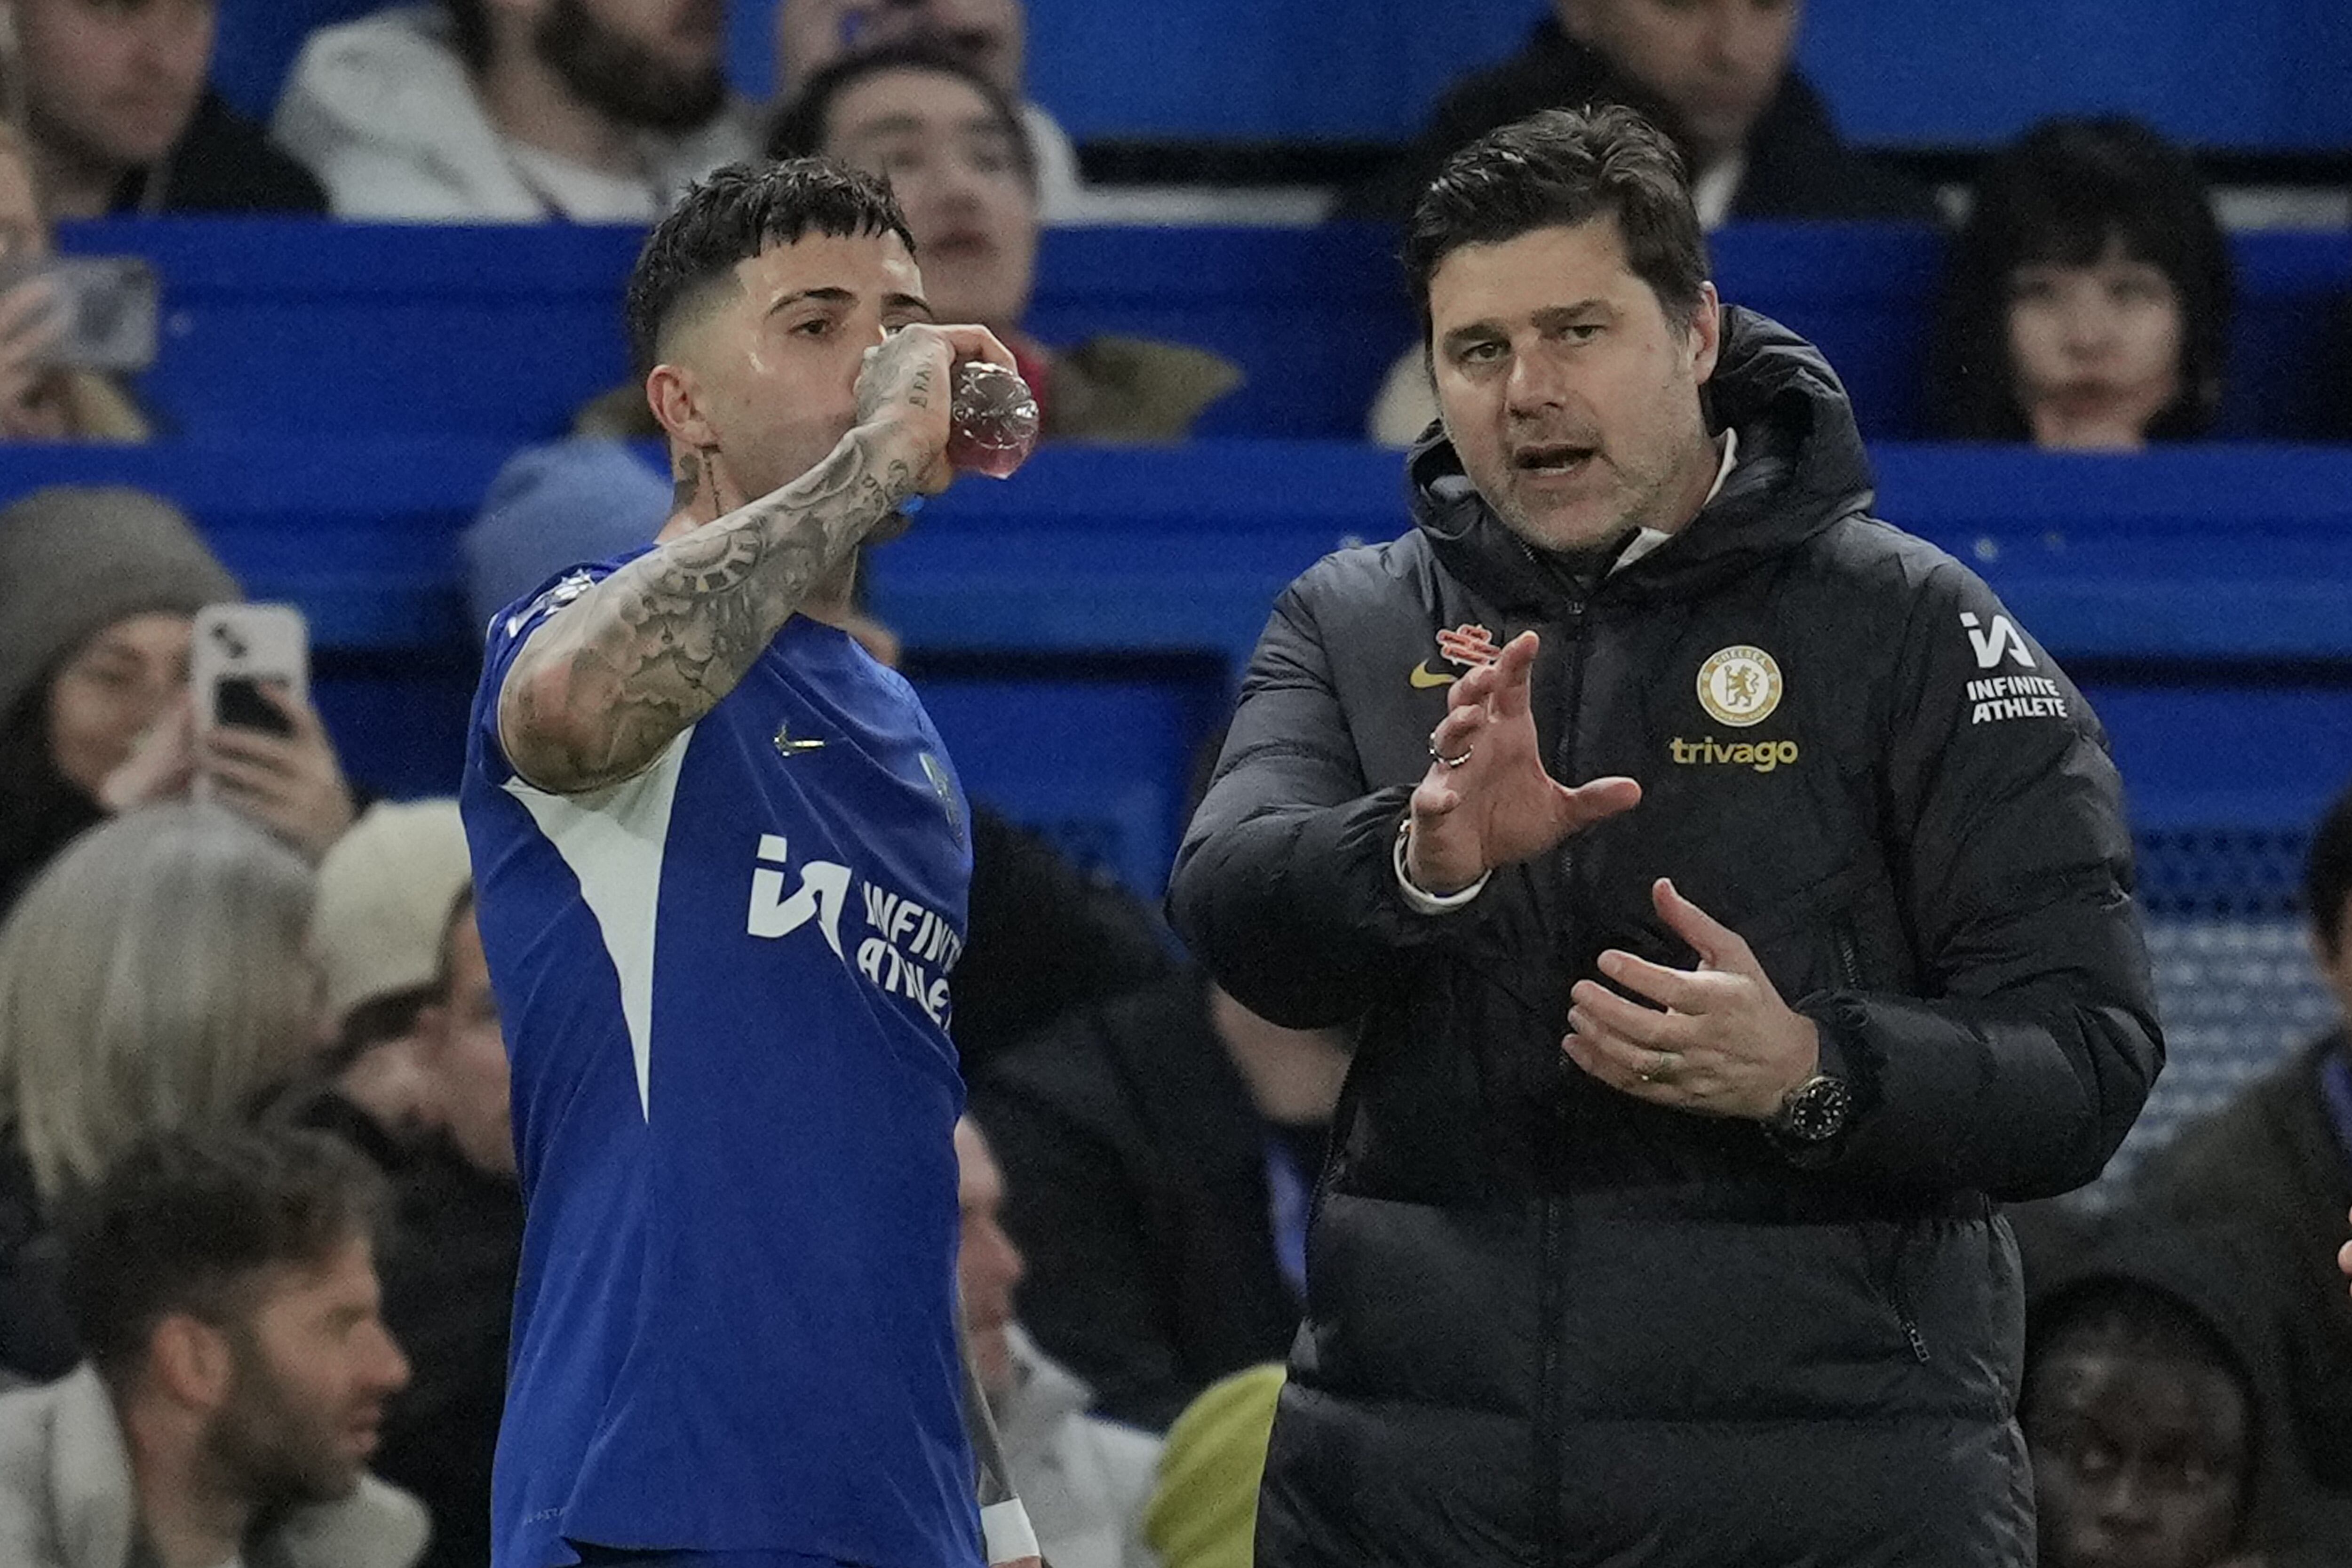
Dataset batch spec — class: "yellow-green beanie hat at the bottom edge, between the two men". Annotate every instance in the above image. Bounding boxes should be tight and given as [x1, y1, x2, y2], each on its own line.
[1143, 1363, 1284, 1568]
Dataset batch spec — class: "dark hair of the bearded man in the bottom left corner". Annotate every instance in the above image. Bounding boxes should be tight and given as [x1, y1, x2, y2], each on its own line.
[61, 1126, 388, 1375]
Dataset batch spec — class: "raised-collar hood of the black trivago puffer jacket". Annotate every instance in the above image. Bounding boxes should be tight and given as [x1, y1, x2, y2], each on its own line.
[1404, 306, 1872, 609]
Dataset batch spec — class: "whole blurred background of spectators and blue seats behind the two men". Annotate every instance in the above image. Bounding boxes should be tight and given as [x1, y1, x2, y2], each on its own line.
[0, 0, 2352, 1568]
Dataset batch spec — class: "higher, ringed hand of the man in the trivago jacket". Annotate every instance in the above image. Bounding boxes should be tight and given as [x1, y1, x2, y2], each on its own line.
[1404, 632, 1642, 896]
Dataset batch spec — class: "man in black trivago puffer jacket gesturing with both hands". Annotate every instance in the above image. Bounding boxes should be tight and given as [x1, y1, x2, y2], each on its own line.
[1169, 108, 2164, 1568]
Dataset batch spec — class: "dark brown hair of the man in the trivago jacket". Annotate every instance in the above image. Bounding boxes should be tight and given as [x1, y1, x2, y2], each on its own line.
[1404, 103, 1708, 341]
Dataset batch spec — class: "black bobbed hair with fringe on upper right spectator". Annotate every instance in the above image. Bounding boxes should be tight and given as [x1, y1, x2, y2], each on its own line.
[1926, 115, 2234, 442]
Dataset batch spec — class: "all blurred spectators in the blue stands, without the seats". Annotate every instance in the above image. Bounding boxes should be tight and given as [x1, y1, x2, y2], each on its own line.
[0, 0, 2352, 1568]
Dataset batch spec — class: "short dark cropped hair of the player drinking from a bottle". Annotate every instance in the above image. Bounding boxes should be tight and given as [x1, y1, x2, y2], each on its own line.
[626, 158, 915, 376]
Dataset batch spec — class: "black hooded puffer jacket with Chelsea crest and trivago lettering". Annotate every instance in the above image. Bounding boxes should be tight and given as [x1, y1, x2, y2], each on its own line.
[1169, 310, 2161, 1568]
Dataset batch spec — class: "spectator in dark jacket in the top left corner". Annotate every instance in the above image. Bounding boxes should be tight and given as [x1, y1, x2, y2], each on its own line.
[12, 0, 327, 219]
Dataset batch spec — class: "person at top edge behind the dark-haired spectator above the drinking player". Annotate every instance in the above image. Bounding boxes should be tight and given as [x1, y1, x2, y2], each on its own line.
[776, 0, 1087, 223]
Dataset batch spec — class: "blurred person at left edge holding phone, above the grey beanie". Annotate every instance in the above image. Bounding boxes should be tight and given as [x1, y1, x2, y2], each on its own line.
[0, 122, 148, 442]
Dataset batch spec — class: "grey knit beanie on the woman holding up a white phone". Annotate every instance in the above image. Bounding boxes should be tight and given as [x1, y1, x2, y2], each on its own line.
[0, 484, 245, 715]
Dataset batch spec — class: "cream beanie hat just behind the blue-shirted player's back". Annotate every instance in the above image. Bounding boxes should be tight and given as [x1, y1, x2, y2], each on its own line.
[310, 799, 473, 1027]
